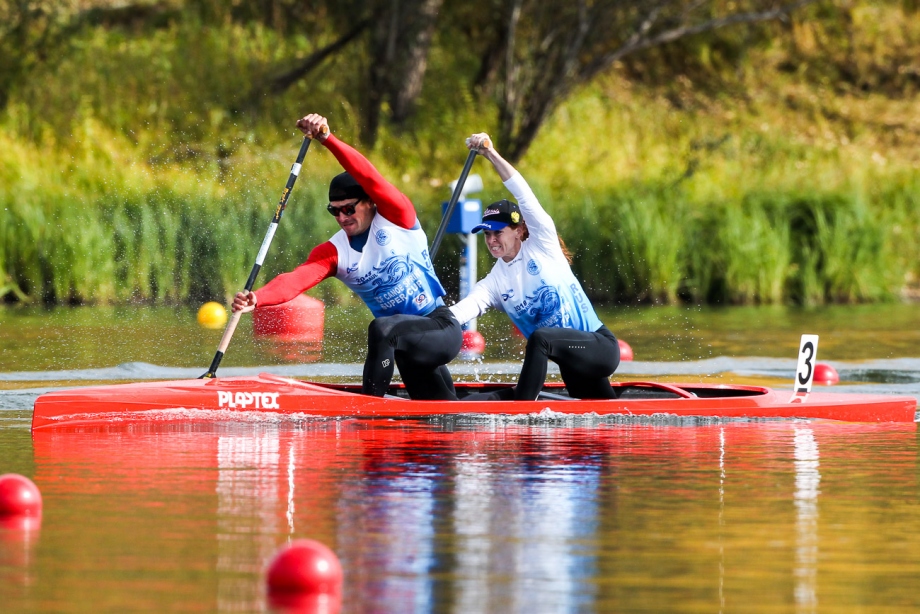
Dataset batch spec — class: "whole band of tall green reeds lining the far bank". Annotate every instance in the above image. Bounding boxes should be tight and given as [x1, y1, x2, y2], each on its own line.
[0, 124, 920, 304]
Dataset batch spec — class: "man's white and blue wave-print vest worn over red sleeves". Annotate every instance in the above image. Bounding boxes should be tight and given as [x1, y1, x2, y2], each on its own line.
[329, 213, 445, 318]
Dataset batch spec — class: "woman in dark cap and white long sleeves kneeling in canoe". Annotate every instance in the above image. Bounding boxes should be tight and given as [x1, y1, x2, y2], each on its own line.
[450, 133, 620, 401]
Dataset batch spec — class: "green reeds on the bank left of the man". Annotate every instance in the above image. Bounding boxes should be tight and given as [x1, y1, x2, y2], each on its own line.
[0, 125, 344, 304]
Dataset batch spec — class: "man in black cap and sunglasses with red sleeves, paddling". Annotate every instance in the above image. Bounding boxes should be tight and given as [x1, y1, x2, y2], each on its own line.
[233, 113, 462, 400]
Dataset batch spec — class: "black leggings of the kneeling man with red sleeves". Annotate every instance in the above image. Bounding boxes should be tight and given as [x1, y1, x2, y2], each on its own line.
[363, 307, 463, 401]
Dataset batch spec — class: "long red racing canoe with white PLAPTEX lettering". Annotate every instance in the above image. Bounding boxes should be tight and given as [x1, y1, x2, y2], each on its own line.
[32, 373, 917, 430]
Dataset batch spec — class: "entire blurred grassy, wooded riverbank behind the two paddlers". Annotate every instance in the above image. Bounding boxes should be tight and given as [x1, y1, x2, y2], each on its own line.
[0, 0, 920, 305]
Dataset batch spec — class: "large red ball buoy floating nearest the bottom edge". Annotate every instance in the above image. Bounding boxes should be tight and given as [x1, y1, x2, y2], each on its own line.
[267, 539, 342, 595]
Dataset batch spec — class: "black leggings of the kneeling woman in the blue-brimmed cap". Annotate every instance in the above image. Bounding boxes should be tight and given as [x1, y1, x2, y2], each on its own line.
[514, 326, 620, 401]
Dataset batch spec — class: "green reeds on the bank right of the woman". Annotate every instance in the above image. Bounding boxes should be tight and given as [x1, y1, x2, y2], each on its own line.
[557, 187, 920, 304]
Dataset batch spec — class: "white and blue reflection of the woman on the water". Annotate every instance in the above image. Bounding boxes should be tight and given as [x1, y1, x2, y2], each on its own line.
[452, 455, 600, 612]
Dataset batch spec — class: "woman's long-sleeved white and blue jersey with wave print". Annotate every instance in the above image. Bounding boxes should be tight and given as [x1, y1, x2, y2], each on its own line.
[450, 173, 603, 338]
